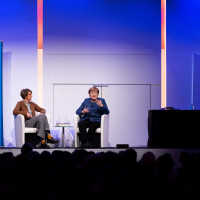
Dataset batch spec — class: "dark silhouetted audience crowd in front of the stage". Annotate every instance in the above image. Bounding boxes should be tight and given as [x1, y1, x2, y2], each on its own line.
[0, 144, 200, 200]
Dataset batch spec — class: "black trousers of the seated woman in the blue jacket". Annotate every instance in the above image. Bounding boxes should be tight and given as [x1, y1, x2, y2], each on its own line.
[78, 119, 100, 143]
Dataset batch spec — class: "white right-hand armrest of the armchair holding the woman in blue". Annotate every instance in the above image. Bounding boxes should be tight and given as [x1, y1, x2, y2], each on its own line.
[101, 114, 110, 147]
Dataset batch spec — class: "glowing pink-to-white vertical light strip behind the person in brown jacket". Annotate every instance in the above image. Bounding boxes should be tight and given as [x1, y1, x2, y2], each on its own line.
[37, 0, 43, 107]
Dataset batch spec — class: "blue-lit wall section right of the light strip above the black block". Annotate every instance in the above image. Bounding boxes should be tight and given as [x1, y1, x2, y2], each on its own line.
[167, 0, 200, 110]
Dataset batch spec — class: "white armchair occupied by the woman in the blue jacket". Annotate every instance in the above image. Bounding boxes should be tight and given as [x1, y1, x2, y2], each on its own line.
[74, 114, 110, 147]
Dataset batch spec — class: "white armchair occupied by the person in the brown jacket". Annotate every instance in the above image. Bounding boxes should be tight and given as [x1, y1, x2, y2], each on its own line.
[14, 114, 50, 147]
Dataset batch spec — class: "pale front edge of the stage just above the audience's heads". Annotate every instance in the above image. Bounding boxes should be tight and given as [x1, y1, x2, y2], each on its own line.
[0, 147, 200, 169]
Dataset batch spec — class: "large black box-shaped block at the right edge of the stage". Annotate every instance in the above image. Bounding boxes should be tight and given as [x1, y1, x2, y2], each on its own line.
[147, 110, 200, 148]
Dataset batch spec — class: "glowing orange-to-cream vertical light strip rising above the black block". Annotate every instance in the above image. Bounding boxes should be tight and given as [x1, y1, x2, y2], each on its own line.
[161, 0, 167, 108]
